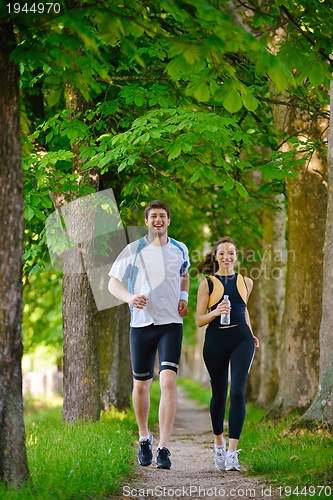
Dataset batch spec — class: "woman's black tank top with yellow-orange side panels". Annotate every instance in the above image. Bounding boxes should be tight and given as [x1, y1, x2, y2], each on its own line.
[207, 273, 248, 327]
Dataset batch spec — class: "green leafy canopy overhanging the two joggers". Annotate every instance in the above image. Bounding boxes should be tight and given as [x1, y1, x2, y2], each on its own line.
[1, 0, 326, 354]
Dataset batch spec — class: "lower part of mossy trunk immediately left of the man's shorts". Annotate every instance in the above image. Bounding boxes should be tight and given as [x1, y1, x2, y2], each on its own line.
[97, 304, 132, 411]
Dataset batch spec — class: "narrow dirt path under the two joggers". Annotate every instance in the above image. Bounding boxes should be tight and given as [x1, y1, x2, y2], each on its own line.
[122, 389, 281, 500]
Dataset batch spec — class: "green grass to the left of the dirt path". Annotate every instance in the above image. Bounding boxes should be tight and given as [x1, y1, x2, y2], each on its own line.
[0, 384, 159, 500]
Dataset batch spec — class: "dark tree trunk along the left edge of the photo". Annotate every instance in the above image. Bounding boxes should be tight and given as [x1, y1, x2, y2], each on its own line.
[0, 20, 29, 486]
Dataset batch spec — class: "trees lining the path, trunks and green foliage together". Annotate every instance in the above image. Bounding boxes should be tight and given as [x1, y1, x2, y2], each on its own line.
[0, 0, 333, 484]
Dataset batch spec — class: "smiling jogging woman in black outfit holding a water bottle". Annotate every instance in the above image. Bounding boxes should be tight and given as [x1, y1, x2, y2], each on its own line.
[196, 237, 259, 471]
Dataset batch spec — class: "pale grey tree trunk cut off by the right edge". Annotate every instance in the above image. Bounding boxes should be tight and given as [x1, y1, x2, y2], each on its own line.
[302, 82, 333, 426]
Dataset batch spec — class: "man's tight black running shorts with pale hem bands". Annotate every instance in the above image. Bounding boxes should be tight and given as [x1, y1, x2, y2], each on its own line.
[130, 323, 183, 380]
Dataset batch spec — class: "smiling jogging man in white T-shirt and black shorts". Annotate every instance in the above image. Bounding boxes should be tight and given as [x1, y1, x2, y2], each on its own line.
[109, 200, 189, 469]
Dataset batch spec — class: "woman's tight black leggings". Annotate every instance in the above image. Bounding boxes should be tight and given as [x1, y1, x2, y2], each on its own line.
[203, 325, 254, 439]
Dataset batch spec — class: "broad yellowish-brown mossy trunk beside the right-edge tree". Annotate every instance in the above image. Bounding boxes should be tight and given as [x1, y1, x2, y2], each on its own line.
[274, 106, 327, 410]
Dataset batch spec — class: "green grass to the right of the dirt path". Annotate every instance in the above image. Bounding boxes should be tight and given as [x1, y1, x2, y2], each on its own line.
[179, 379, 333, 498]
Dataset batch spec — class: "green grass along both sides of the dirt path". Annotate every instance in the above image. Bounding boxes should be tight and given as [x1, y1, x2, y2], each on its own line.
[5, 379, 333, 500]
